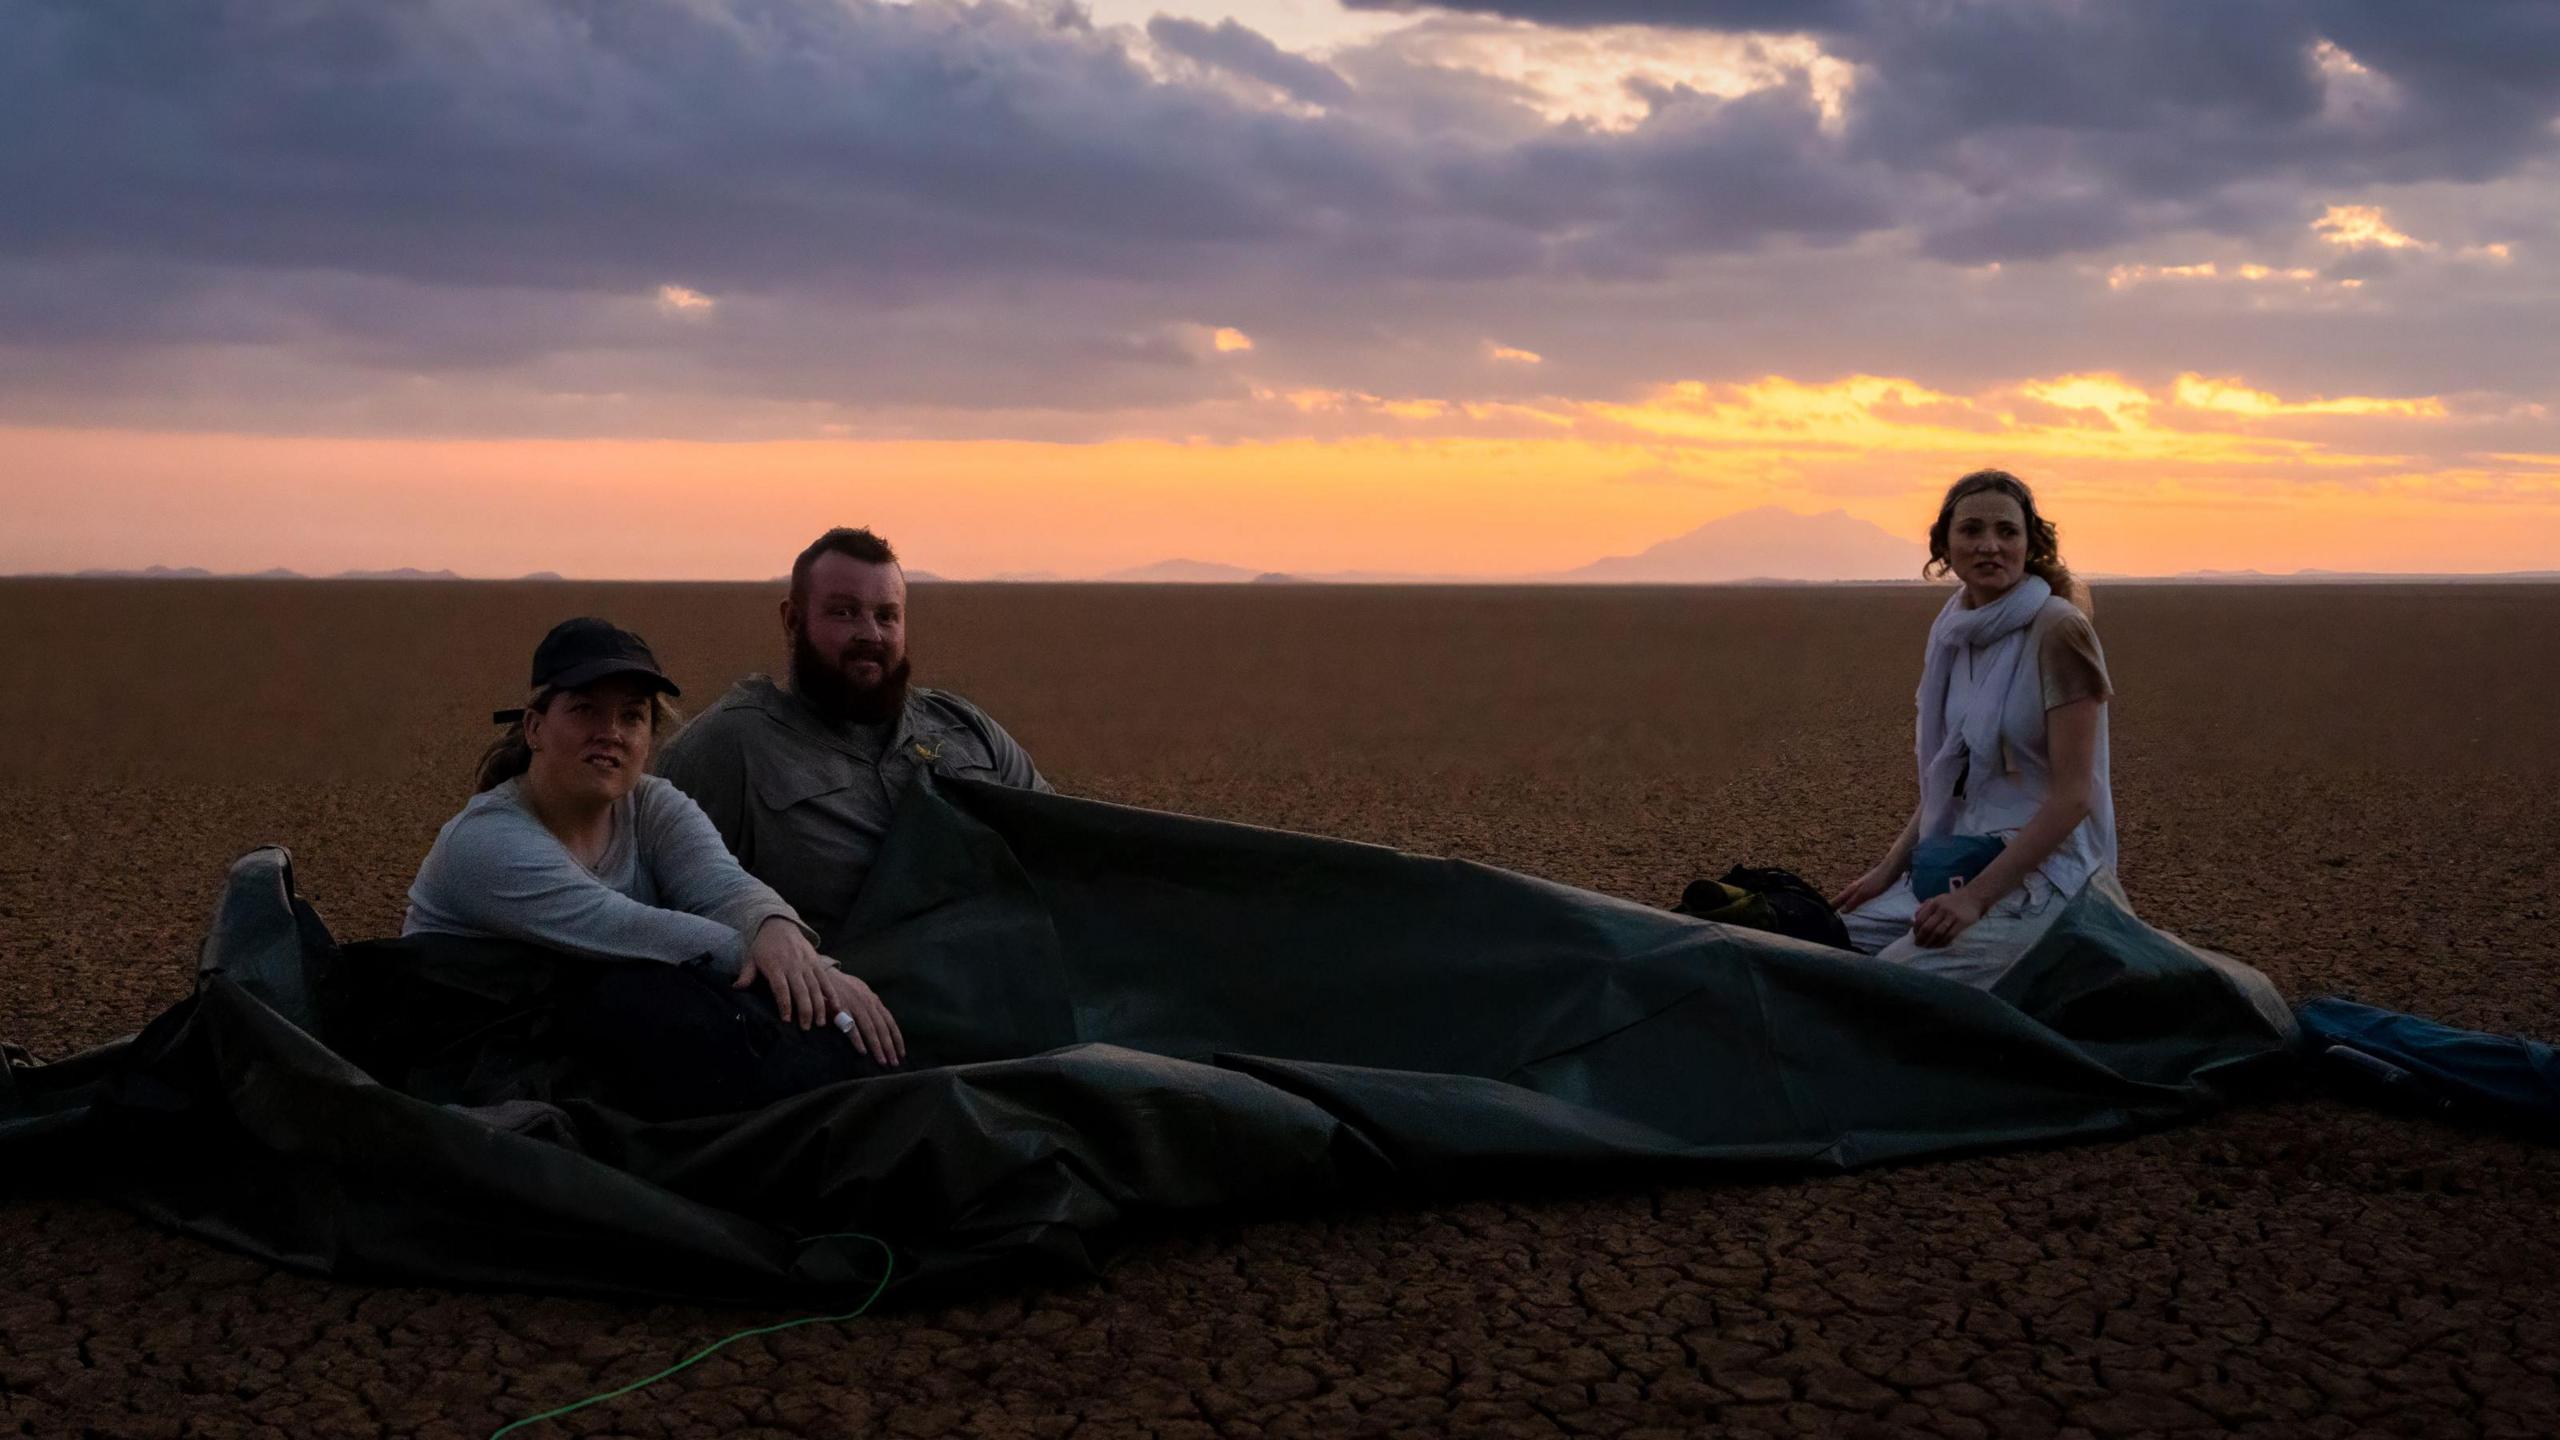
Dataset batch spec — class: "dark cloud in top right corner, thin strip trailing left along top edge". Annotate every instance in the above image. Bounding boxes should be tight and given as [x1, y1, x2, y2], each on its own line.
[1347, 0, 2560, 245]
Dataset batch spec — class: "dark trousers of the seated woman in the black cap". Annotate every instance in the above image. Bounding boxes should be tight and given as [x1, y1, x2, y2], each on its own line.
[561, 961, 883, 1120]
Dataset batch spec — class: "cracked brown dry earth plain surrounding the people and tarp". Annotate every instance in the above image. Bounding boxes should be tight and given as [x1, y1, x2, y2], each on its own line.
[0, 582, 2560, 1440]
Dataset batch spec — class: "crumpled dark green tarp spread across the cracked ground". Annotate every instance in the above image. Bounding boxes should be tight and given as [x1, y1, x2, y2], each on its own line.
[0, 781, 2291, 1304]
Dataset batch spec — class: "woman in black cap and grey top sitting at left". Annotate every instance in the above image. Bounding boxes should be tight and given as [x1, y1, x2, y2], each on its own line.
[402, 618, 906, 1112]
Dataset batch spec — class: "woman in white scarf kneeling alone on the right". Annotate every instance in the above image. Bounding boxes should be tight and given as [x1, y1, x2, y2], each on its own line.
[1830, 469, 2115, 986]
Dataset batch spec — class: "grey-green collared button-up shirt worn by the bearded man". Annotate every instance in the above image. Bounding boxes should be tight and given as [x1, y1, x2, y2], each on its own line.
[658, 674, 1052, 940]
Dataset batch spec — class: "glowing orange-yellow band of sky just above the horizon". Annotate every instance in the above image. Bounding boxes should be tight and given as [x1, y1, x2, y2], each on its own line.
[0, 353, 2560, 579]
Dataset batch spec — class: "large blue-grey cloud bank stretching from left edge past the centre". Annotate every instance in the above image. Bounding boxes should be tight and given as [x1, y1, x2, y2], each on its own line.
[0, 0, 1889, 368]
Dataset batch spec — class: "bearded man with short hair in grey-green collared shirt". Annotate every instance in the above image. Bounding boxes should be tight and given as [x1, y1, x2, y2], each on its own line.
[658, 528, 1052, 940]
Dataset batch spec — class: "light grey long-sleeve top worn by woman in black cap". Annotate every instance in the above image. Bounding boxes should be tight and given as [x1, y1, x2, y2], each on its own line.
[399, 776, 817, 976]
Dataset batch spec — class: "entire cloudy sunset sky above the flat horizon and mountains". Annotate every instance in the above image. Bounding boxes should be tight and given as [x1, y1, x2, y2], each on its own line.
[0, 0, 2560, 579]
